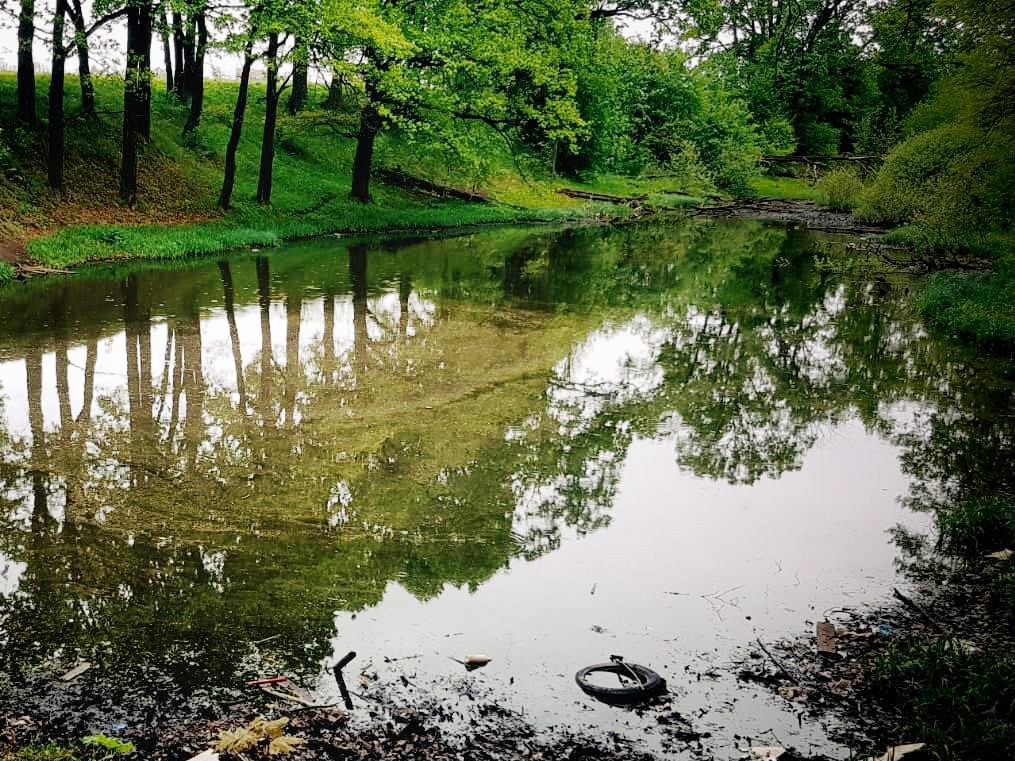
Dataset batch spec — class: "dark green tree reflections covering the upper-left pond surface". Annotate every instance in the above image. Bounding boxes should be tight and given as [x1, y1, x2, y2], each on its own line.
[0, 223, 1015, 683]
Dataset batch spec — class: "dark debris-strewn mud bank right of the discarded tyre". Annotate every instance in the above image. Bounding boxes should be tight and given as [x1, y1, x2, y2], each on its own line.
[738, 562, 1015, 761]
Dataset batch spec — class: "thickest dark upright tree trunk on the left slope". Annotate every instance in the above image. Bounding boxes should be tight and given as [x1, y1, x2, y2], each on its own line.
[120, 0, 151, 207]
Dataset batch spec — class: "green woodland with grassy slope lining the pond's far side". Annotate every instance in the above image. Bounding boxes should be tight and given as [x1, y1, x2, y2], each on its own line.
[0, 0, 1015, 341]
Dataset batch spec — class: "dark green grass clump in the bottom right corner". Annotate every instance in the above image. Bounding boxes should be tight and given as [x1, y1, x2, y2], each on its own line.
[870, 637, 1015, 761]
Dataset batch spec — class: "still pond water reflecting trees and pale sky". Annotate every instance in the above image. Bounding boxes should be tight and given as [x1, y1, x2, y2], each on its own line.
[0, 222, 1013, 750]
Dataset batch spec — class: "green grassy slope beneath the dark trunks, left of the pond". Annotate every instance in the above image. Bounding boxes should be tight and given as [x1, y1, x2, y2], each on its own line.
[0, 74, 676, 267]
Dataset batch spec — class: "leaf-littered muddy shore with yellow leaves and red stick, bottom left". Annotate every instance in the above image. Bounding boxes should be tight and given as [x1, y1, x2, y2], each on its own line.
[0, 673, 828, 761]
